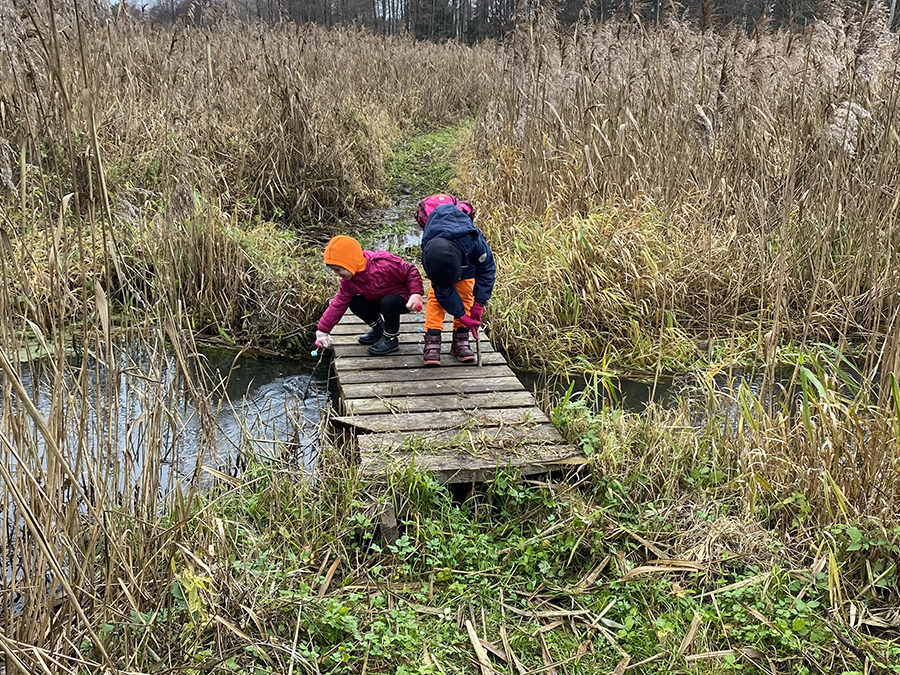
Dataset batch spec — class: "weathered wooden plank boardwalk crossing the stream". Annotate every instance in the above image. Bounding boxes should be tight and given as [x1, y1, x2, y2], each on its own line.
[331, 312, 584, 483]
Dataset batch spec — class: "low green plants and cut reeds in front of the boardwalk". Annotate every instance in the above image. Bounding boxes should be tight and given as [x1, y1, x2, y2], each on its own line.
[83, 446, 900, 675]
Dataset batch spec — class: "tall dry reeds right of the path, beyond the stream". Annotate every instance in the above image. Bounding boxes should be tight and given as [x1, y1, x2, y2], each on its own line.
[469, 5, 900, 374]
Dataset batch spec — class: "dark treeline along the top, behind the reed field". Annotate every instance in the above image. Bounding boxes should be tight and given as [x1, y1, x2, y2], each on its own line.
[128, 0, 900, 43]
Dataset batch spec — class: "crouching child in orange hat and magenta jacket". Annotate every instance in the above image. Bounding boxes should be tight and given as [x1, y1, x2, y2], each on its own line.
[316, 235, 425, 356]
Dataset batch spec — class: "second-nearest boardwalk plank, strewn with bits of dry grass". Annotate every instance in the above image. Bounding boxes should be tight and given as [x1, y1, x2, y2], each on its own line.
[357, 424, 566, 453]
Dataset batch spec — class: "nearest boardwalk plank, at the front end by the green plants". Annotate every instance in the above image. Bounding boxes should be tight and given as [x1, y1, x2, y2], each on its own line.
[360, 445, 586, 483]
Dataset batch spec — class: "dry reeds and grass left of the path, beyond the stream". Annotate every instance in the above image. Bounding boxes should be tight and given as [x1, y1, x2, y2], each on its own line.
[0, 15, 492, 343]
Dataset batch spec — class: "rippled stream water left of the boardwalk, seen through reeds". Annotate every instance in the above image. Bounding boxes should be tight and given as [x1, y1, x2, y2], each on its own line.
[7, 340, 333, 493]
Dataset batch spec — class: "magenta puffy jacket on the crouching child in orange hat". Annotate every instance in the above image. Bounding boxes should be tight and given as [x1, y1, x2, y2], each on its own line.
[317, 251, 425, 333]
